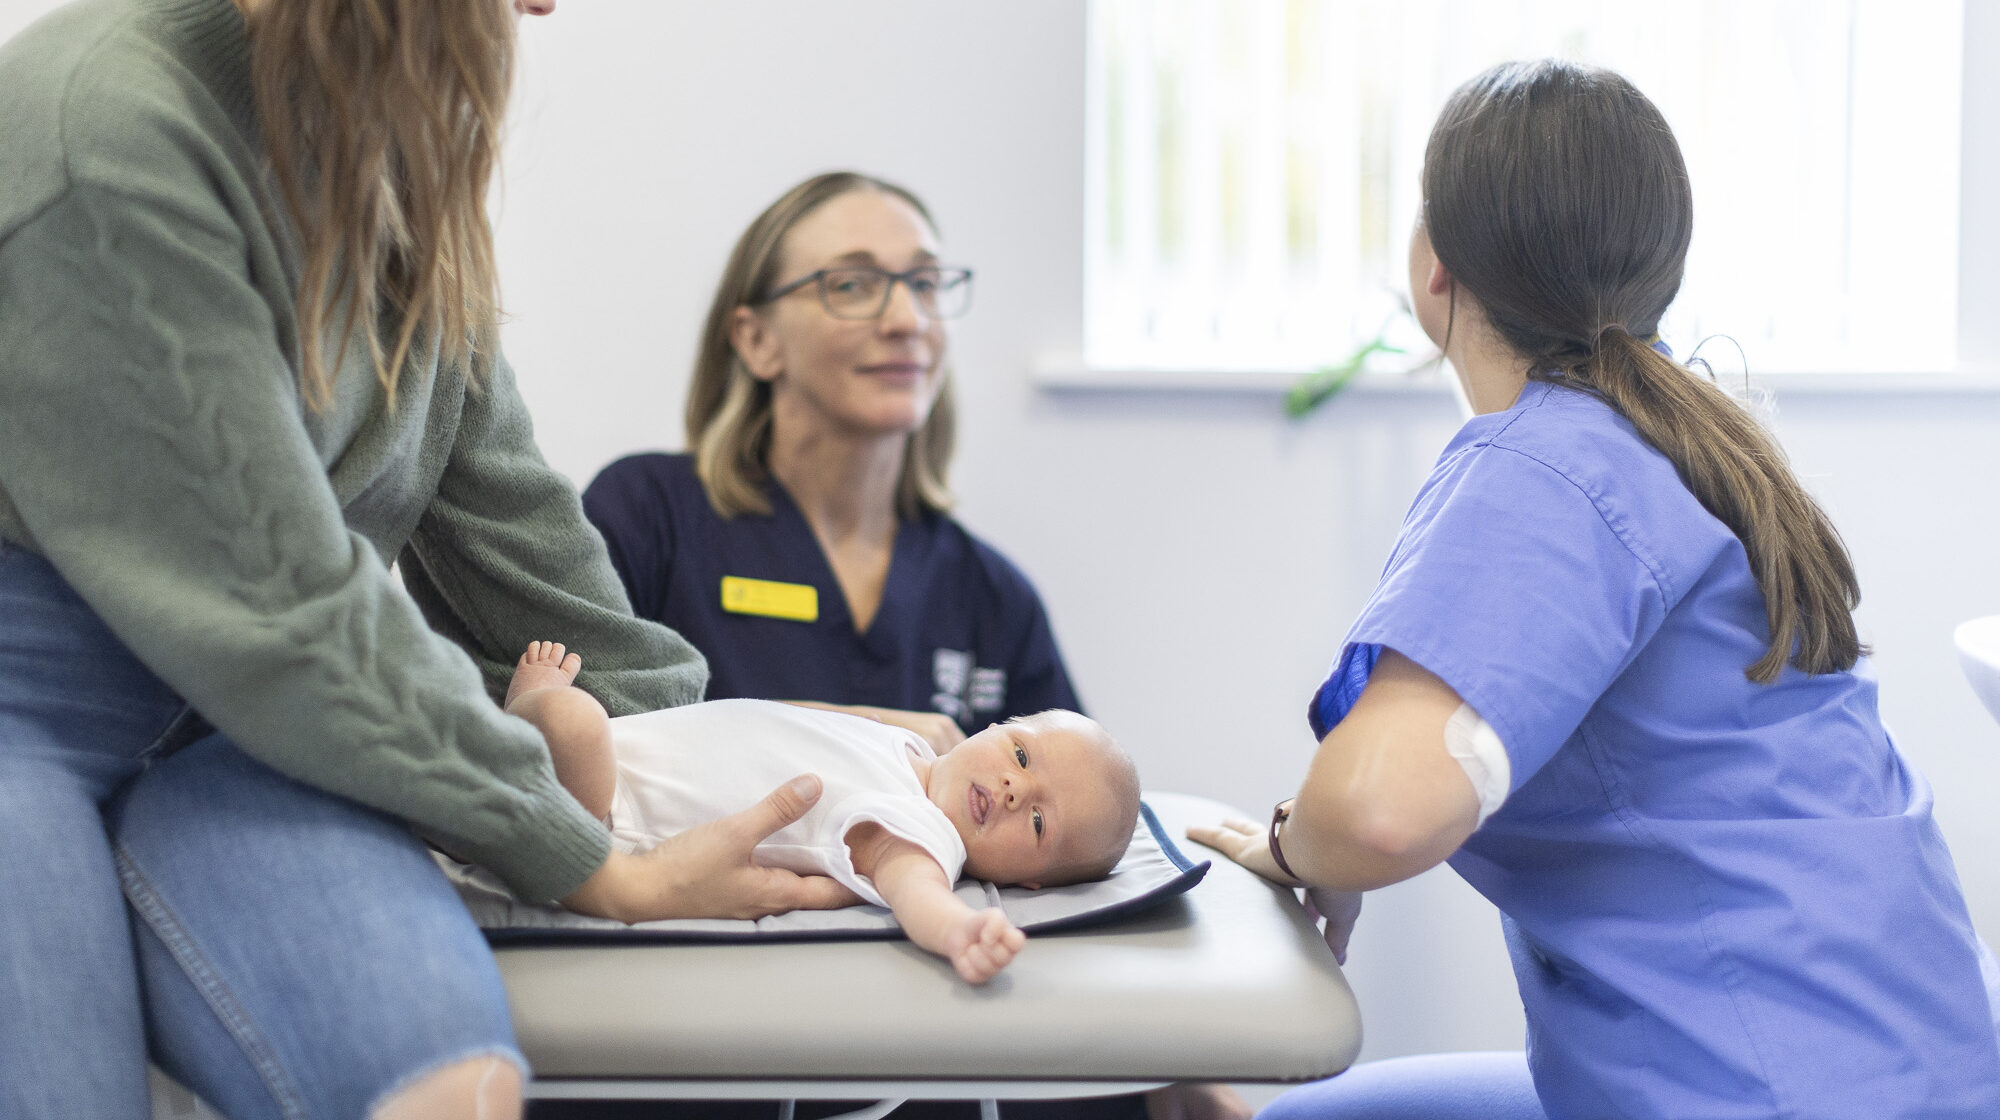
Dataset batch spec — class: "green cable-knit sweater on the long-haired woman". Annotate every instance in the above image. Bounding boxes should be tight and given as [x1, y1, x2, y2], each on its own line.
[0, 0, 706, 900]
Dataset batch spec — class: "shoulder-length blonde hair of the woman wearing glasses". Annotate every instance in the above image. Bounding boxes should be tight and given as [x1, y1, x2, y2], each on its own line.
[686, 172, 958, 520]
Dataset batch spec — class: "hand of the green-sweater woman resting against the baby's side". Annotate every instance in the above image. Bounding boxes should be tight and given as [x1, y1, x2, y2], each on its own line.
[562, 774, 860, 922]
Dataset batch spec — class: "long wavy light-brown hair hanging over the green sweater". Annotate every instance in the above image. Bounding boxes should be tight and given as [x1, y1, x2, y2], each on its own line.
[248, 0, 514, 410]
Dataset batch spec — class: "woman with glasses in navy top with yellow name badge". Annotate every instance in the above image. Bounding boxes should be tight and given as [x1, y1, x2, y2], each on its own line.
[584, 172, 1078, 752]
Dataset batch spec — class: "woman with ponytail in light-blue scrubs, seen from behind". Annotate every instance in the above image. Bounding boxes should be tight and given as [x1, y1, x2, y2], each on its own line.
[1196, 62, 2000, 1120]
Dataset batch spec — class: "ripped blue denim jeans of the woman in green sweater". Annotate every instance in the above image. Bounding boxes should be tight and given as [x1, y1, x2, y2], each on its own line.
[0, 544, 526, 1120]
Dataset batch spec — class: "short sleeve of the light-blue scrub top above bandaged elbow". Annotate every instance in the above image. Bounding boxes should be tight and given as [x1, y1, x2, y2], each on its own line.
[1310, 442, 1668, 788]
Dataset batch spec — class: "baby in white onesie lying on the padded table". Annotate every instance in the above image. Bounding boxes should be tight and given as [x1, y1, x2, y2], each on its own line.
[506, 642, 1138, 984]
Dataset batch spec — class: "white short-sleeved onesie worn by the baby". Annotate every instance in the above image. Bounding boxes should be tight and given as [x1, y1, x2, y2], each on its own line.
[612, 700, 966, 906]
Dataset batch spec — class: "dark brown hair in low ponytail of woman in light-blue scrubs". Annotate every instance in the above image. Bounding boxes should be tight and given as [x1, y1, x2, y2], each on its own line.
[1424, 60, 1864, 684]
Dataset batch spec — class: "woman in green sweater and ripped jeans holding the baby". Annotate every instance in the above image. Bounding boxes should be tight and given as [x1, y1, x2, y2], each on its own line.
[0, 0, 848, 1118]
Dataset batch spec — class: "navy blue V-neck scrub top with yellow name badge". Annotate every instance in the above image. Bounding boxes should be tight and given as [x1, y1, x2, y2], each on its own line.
[584, 452, 1080, 732]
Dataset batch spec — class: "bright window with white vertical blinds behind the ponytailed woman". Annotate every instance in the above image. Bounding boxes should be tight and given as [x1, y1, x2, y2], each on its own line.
[1084, 0, 1964, 372]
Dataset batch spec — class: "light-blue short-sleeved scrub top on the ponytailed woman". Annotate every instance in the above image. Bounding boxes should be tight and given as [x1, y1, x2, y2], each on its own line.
[1312, 382, 2000, 1120]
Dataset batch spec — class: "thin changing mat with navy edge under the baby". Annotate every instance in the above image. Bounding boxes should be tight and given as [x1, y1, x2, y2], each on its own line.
[438, 802, 1208, 946]
